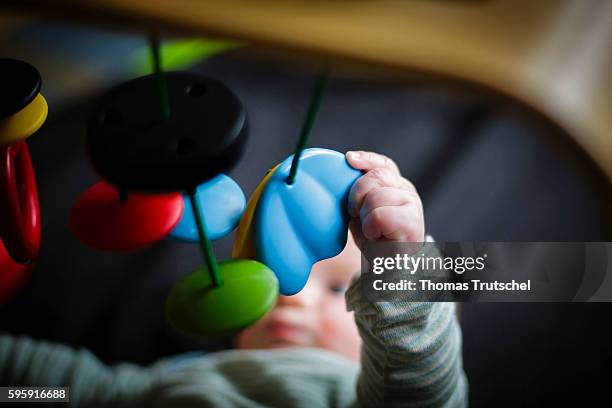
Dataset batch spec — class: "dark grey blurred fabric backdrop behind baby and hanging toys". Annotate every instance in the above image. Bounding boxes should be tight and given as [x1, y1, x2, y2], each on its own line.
[0, 40, 612, 407]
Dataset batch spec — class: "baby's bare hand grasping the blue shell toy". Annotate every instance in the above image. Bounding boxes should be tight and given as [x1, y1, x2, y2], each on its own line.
[346, 151, 425, 247]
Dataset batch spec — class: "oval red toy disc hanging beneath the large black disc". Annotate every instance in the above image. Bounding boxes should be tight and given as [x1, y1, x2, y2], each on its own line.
[70, 181, 183, 251]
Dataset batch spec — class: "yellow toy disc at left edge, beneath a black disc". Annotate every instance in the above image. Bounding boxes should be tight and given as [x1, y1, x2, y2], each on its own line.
[0, 93, 49, 145]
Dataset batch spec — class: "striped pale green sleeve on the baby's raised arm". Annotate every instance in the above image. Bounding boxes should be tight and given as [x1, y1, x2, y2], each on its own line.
[346, 241, 468, 407]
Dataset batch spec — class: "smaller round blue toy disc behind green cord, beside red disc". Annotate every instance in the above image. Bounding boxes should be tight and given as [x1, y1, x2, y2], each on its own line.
[170, 174, 246, 243]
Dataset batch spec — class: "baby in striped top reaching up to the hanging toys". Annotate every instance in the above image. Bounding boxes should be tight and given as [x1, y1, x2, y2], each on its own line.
[0, 152, 467, 407]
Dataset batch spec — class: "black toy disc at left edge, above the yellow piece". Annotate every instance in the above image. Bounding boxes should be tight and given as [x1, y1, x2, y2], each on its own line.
[0, 58, 42, 119]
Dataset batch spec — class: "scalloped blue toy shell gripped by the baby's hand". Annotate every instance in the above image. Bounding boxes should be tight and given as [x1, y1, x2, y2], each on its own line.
[253, 148, 362, 295]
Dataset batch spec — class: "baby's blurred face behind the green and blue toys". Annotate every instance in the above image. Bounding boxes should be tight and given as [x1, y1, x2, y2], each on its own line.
[236, 233, 361, 360]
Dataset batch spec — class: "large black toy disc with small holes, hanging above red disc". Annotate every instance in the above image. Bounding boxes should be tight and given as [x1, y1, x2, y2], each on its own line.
[87, 72, 248, 191]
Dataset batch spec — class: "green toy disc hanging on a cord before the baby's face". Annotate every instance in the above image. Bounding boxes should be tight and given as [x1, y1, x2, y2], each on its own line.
[166, 259, 278, 335]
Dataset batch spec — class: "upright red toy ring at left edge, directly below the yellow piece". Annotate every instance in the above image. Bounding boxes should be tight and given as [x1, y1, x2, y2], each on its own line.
[0, 141, 40, 263]
